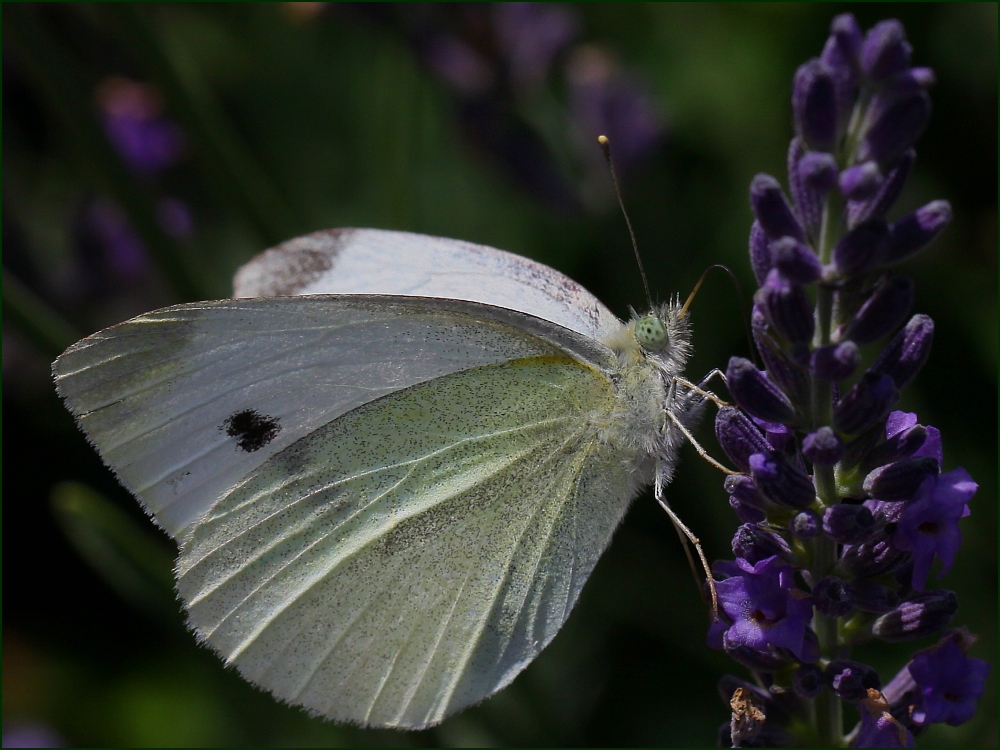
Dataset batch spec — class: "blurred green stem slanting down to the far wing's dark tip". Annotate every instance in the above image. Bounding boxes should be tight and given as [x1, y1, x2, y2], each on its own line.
[103, 3, 302, 245]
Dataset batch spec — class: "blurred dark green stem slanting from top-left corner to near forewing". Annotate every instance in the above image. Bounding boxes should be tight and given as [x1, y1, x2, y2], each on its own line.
[4, 3, 210, 300]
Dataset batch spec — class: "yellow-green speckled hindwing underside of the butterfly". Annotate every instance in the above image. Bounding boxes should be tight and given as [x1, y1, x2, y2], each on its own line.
[178, 356, 634, 727]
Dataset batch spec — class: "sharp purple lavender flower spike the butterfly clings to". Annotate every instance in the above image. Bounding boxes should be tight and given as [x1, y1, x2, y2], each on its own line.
[709, 14, 989, 747]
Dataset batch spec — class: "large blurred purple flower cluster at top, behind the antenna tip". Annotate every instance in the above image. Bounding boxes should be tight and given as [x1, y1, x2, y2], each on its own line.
[352, 3, 664, 212]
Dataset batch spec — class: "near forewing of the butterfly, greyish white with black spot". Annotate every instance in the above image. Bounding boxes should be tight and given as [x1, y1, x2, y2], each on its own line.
[54, 295, 606, 538]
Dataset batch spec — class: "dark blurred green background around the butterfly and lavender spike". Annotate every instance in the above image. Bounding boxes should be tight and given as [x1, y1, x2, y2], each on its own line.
[2, 3, 997, 747]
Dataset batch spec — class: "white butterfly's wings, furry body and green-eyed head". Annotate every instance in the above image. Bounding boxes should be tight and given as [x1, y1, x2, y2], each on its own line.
[53, 229, 702, 728]
